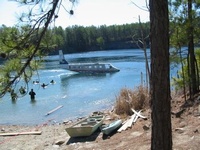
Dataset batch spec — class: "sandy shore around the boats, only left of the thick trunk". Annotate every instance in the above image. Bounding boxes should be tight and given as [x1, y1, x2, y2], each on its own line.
[0, 110, 151, 150]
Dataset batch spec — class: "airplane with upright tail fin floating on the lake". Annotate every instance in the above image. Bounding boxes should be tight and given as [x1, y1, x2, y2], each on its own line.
[59, 50, 120, 73]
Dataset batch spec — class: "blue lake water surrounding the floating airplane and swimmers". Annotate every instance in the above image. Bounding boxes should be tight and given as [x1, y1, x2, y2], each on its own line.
[0, 49, 175, 125]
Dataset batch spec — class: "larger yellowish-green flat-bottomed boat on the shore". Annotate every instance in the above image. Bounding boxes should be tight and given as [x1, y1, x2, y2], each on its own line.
[65, 115, 105, 137]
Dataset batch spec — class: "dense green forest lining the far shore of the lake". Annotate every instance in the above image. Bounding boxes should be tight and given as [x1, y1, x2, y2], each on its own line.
[0, 22, 150, 55]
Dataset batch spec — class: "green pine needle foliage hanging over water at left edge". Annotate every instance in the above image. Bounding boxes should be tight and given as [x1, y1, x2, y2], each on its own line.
[0, 26, 41, 96]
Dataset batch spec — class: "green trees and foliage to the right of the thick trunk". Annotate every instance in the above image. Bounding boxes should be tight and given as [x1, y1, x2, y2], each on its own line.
[169, 0, 200, 94]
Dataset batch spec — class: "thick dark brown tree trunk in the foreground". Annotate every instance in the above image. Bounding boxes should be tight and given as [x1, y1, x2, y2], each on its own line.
[149, 0, 172, 150]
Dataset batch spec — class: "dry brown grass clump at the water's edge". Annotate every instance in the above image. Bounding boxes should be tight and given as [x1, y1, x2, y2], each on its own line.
[115, 86, 149, 116]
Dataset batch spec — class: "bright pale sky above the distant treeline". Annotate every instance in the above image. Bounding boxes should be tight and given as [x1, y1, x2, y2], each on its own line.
[0, 0, 149, 28]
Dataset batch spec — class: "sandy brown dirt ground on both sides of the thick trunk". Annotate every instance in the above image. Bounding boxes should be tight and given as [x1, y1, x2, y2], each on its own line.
[0, 94, 200, 150]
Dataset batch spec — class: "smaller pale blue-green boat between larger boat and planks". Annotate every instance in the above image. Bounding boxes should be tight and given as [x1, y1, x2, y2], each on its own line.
[101, 119, 122, 135]
